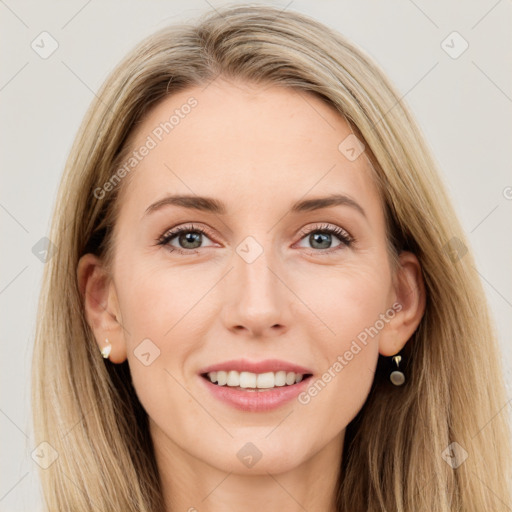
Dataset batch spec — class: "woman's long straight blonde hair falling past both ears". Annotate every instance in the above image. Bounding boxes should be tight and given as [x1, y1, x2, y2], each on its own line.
[32, 5, 511, 512]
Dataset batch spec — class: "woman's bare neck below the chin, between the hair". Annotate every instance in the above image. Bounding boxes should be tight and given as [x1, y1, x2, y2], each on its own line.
[153, 424, 344, 512]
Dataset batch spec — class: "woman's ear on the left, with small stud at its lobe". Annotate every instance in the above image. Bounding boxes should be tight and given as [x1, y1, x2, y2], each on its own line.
[77, 254, 126, 363]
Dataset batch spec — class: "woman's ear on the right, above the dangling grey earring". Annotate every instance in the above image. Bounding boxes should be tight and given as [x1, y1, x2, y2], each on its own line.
[379, 251, 426, 356]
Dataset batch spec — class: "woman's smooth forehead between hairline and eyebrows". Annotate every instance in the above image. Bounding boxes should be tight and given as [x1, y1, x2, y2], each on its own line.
[115, 80, 379, 219]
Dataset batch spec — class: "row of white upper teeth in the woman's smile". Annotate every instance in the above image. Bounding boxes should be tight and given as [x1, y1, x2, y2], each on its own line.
[208, 370, 304, 389]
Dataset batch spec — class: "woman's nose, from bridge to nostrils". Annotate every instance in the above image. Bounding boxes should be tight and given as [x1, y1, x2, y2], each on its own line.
[222, 241, 293, 338]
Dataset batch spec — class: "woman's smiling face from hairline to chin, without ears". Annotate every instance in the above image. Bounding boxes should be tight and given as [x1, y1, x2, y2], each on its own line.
[100, 80, 395, 474]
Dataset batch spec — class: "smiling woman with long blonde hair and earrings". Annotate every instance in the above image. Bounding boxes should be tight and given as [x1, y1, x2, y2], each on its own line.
[33, 6, 510, 512]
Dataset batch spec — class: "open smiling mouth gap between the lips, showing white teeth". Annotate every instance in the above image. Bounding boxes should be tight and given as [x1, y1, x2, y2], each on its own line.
[201, 370, 312, 392]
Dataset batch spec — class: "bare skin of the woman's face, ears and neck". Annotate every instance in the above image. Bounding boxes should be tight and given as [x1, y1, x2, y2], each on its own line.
[78, 79, 425, 512]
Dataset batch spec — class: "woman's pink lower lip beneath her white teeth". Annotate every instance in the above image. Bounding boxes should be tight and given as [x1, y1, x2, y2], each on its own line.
[199, 376, 311, 412]
